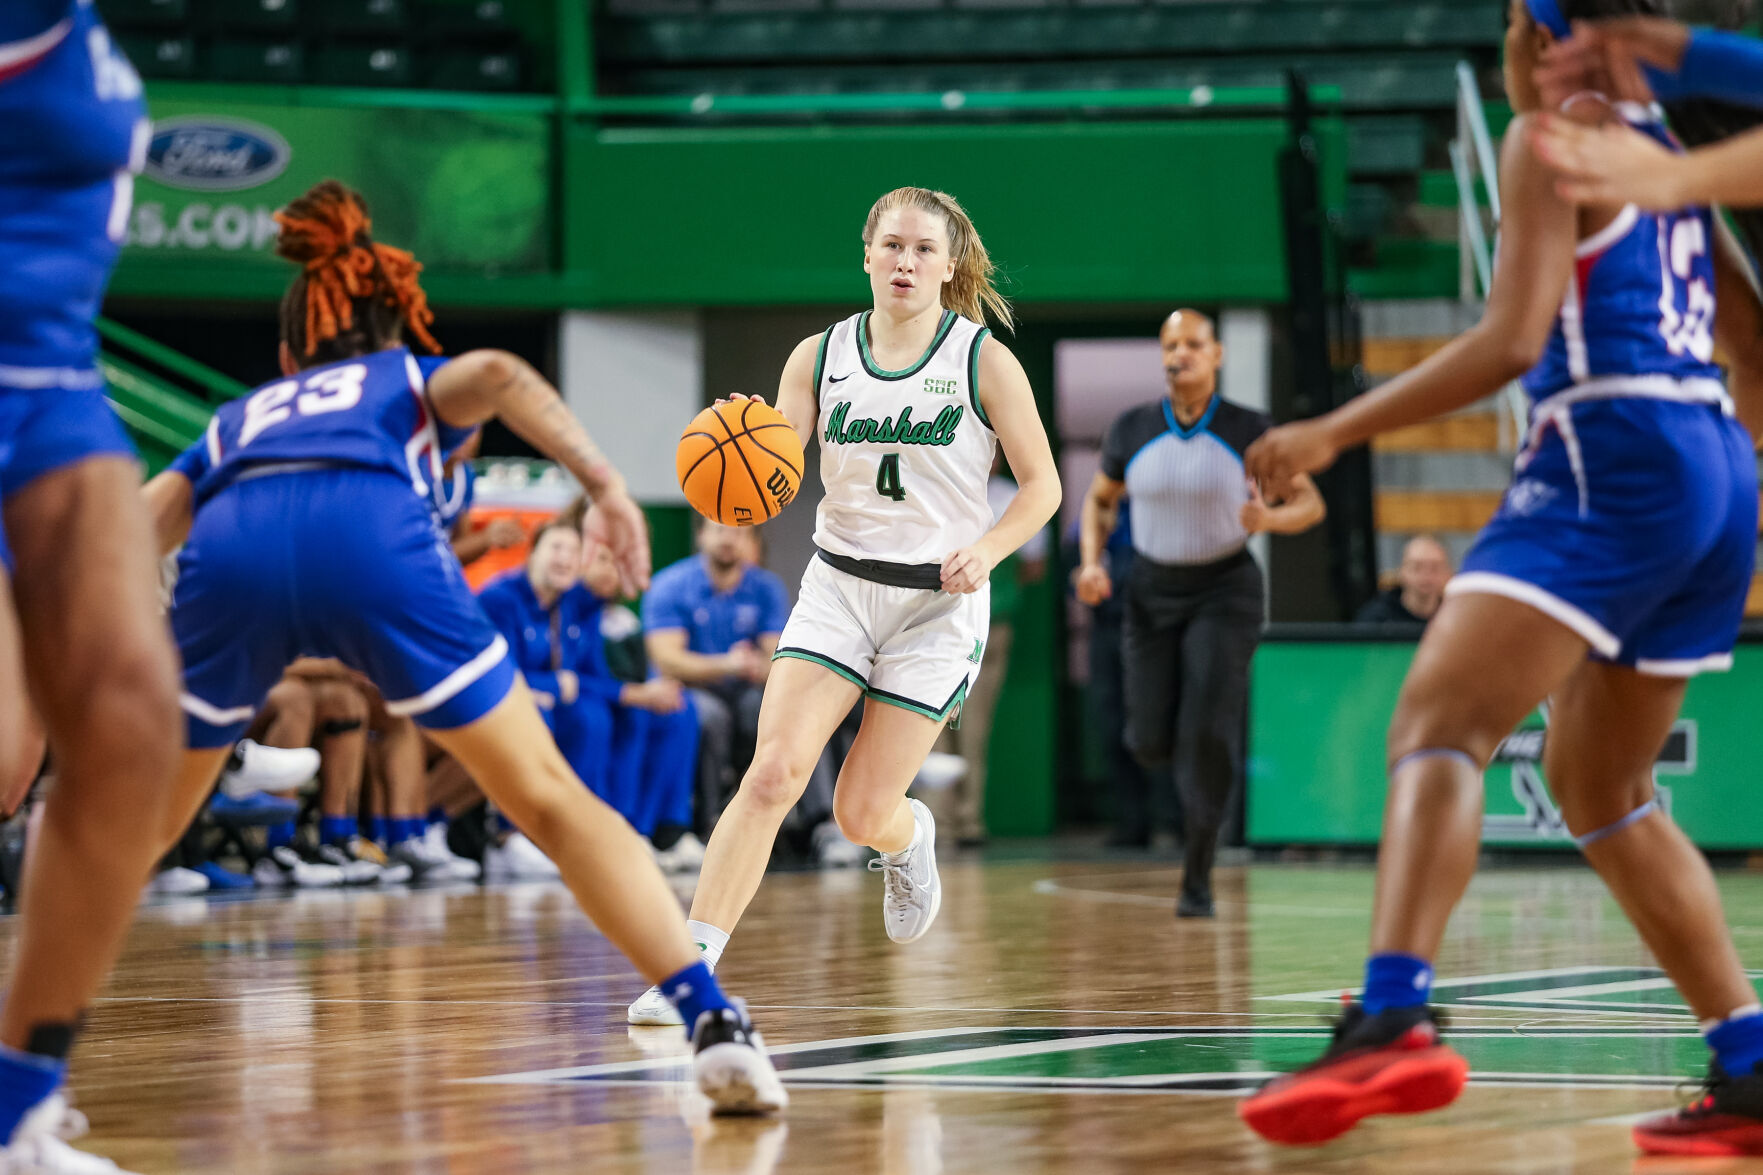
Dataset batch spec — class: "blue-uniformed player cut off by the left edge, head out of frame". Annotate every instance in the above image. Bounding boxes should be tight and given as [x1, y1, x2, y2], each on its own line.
[0, 0, 182, 1175]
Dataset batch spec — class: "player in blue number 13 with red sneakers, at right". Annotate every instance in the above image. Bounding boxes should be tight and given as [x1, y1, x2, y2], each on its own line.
[1241, 0, 1763, 1154]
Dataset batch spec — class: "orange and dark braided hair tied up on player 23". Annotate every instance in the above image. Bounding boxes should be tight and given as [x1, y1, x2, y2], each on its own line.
[275, 180, 441, 367]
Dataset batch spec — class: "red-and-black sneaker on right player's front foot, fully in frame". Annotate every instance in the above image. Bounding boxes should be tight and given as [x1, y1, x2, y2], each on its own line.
[1236, 1004, 1469, 1147]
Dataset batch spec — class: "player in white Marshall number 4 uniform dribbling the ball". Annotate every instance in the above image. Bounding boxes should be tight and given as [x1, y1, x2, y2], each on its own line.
[629, 187, 1060, 1023]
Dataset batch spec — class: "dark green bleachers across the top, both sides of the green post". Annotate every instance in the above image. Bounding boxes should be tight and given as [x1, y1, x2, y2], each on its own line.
[102, 0, 1504, 293]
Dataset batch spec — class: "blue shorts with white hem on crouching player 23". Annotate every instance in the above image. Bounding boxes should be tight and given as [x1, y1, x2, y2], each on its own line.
[171, 468, 515, 748]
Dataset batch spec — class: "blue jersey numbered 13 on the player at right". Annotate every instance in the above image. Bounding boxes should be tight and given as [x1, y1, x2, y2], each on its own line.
[1521, 104, 1722, 400]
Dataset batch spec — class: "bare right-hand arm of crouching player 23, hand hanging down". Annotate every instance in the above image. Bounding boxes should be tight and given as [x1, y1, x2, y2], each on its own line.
[428, 351, 649, 585]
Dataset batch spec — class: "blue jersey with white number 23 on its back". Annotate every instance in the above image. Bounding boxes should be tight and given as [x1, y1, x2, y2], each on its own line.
[171, 348, 471, 510]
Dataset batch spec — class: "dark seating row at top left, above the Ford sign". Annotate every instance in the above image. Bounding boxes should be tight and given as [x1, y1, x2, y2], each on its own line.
[104, 0, 525, 90]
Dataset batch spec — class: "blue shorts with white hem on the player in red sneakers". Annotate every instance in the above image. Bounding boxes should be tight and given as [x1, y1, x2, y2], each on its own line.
[1446, 399, 1758, 677]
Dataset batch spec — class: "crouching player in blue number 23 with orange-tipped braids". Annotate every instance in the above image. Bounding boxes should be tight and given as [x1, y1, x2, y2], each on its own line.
[146, 180, 786, 1113]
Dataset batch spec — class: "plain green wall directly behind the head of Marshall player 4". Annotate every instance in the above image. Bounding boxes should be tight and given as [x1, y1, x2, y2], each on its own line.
[561, 118, 1340, 305]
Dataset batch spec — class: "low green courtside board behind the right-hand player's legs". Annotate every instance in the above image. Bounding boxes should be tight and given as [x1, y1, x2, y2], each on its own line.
[1248, 640, 1763, 849]
